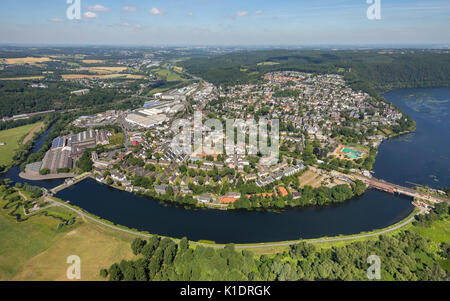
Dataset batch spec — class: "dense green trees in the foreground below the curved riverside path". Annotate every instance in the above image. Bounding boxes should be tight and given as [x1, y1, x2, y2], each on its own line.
[100, 204, 450, 281]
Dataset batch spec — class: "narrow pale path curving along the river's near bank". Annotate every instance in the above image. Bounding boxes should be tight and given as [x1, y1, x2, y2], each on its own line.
[47, 198, 423, 249]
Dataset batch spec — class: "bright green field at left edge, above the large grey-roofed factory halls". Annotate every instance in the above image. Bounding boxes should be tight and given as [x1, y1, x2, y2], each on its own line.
[0, 123, 39, 165]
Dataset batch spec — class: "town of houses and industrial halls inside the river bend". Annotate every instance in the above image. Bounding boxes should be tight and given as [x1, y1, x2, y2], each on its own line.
[18, 71, 408, 209]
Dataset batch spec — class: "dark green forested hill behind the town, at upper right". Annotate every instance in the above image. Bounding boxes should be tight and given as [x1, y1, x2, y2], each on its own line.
[181, 50, 450, 91]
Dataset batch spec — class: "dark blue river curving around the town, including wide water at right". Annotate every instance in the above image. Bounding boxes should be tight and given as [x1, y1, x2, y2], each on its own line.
[4, 88, 450, 243]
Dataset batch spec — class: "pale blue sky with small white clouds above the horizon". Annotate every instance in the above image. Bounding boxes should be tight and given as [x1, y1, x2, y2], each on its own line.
[0, 0, 450, 46]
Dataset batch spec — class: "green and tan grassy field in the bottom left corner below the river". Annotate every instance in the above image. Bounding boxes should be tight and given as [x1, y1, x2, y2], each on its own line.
[0, 196, 134, 281]
